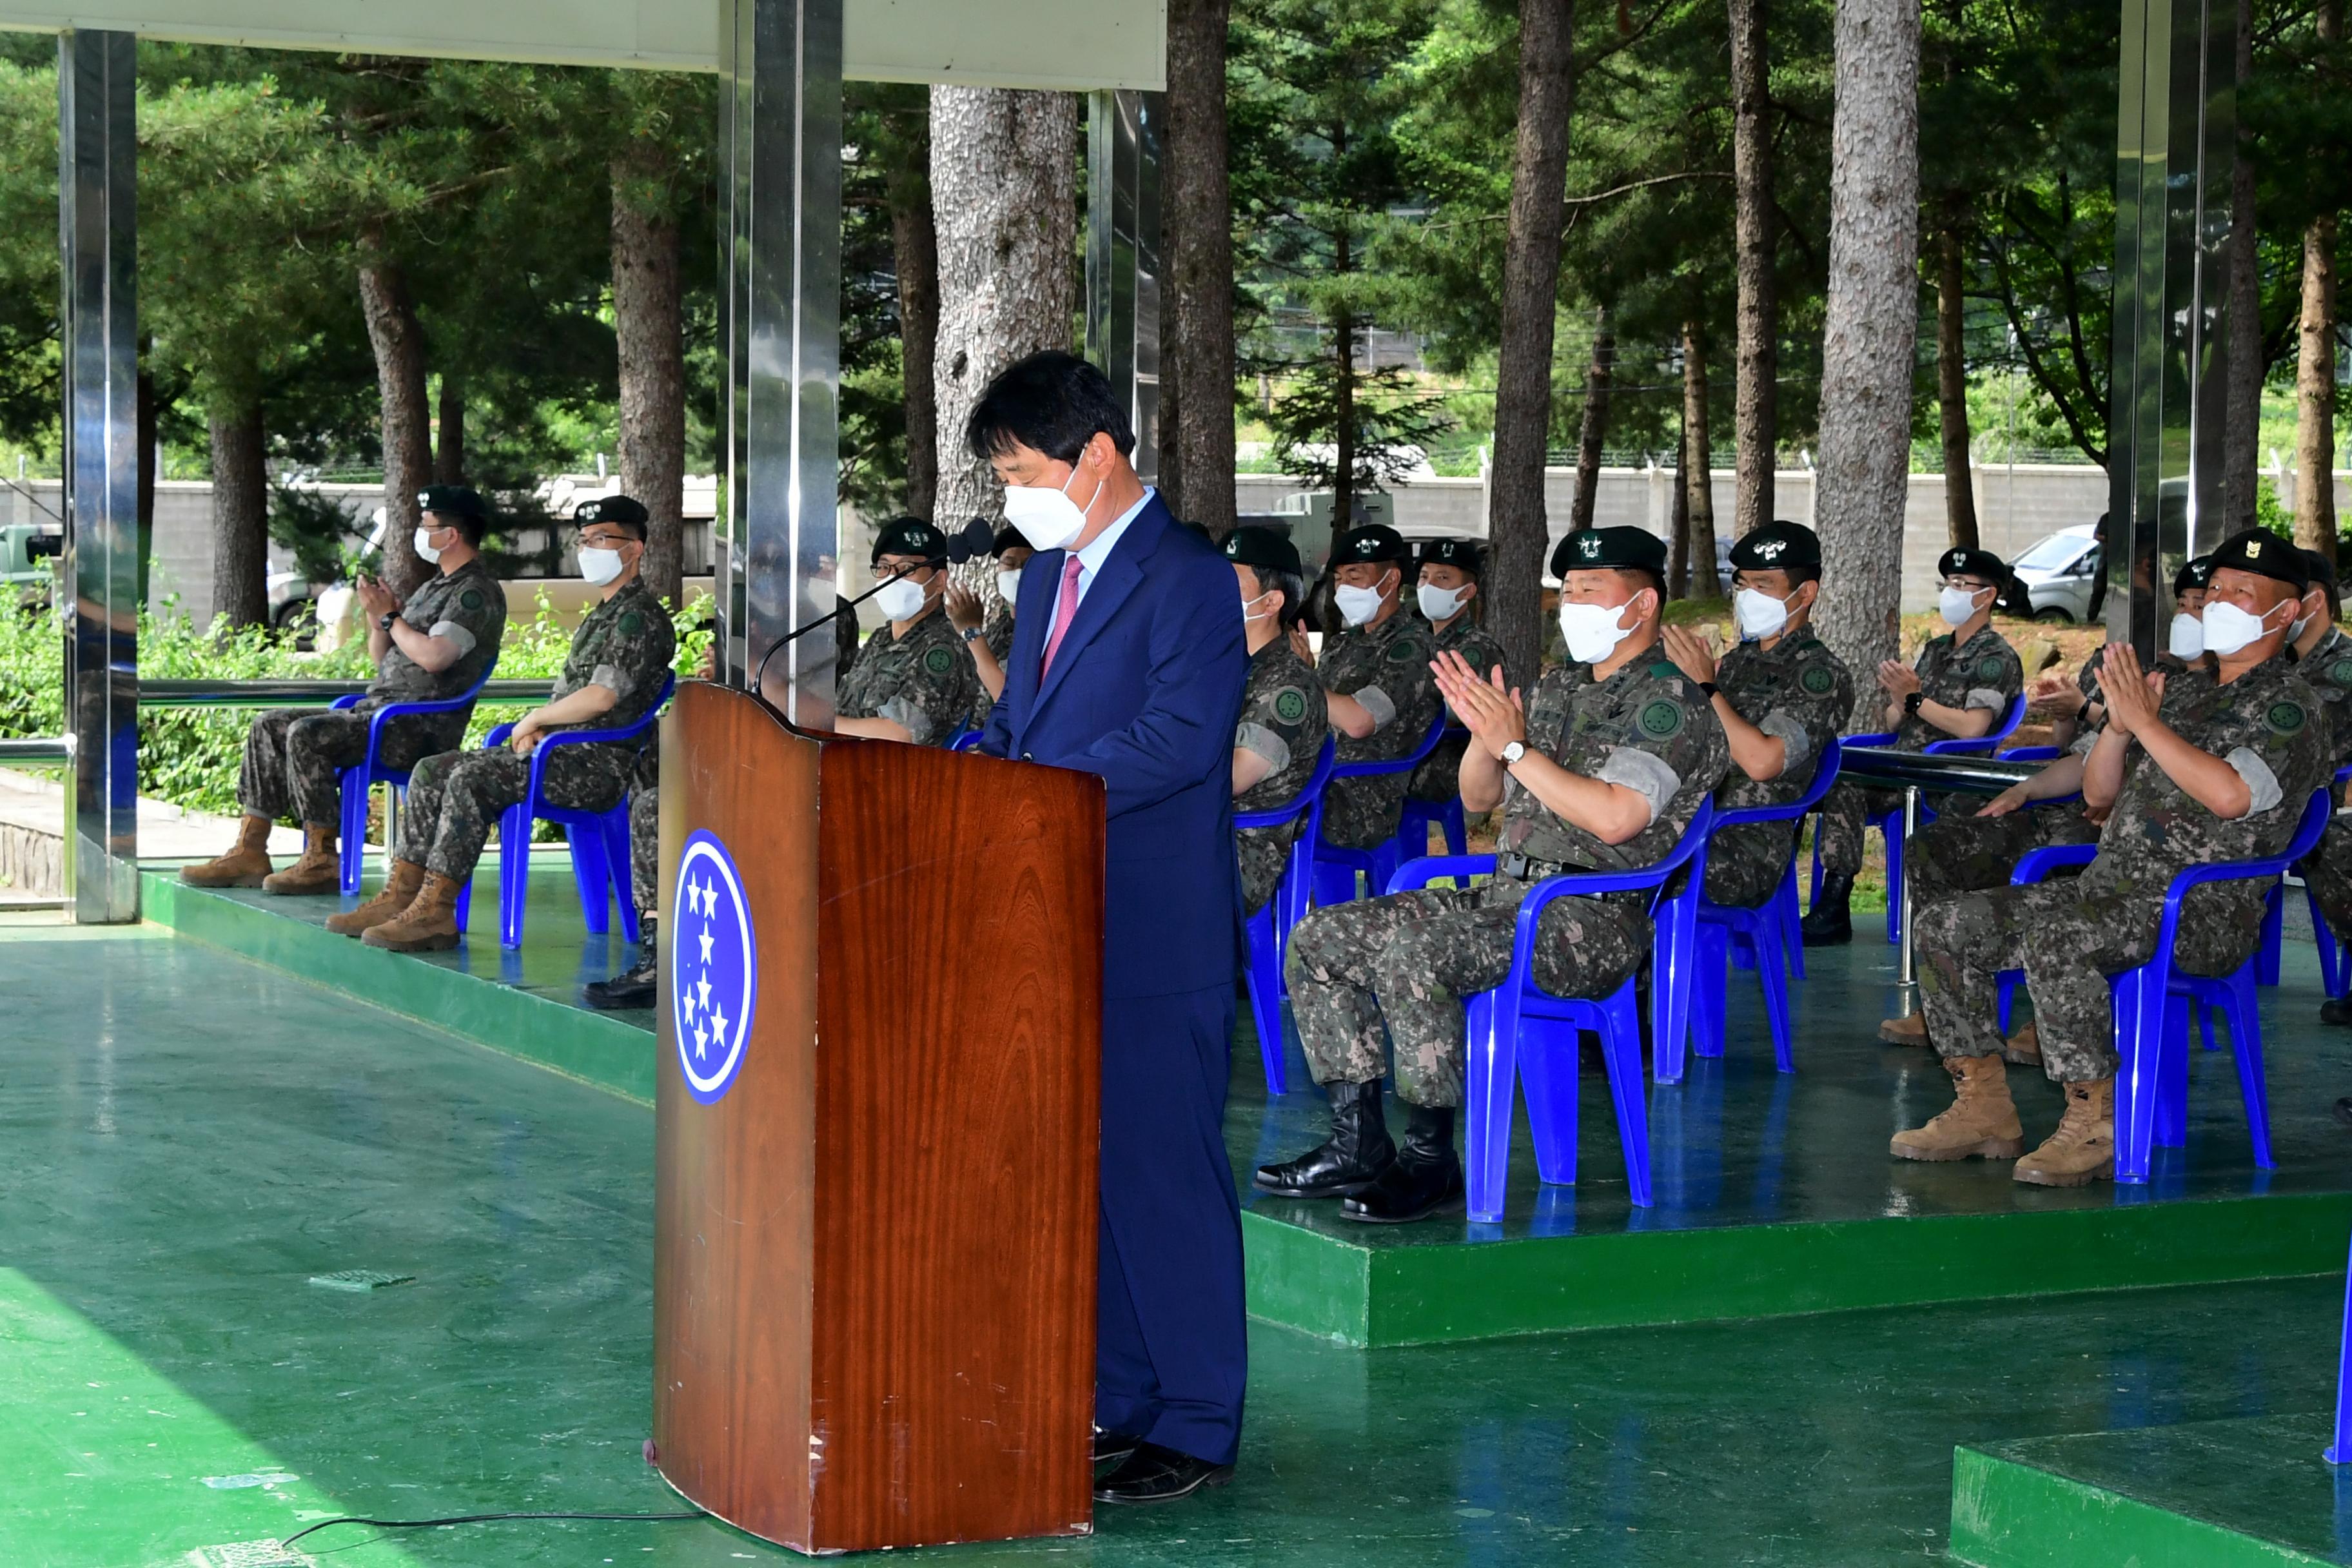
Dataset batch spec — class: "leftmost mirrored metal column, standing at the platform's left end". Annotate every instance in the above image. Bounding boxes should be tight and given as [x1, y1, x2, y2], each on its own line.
[57, 30, 139, 924]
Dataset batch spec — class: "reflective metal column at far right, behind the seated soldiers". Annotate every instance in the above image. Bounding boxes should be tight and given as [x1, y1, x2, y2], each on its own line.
[2108, 0, 2237, 658]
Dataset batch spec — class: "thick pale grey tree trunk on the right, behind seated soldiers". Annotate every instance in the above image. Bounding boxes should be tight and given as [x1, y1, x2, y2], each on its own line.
[1814, 0, 1919, 705]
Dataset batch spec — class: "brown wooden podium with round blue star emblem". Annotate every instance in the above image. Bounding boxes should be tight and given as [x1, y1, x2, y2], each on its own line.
[654, 681, 1103, 1551]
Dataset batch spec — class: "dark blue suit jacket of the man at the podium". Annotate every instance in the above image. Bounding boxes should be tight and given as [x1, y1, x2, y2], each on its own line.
[981, 494, 1249, 997]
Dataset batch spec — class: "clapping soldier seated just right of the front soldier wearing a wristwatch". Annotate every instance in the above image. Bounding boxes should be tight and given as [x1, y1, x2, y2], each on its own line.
[1665, 522, 1854, 910]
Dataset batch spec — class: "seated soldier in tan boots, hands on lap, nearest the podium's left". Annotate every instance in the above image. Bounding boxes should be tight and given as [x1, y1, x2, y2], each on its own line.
[327, 496, 678, 952]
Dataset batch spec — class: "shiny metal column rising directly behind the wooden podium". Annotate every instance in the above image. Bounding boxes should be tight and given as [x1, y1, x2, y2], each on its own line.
[718, 0, 842, 729]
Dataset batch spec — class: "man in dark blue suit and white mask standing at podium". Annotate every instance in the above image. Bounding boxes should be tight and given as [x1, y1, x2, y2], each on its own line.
[966, 353, 1249, 1502]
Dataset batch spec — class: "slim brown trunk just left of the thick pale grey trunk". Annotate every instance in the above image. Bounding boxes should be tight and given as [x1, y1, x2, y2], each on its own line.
[1731, 0, 1781, 534]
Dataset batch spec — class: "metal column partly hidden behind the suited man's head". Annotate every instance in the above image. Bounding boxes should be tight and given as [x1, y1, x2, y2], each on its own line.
[1086, 90, 1164, 482]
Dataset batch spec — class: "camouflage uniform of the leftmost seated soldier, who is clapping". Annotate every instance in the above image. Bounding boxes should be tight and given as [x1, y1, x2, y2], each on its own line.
[237, 557, 505, 827]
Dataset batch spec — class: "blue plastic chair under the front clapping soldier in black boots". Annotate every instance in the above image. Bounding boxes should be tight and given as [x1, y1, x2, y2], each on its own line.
[1387, 801, 1714, 1225]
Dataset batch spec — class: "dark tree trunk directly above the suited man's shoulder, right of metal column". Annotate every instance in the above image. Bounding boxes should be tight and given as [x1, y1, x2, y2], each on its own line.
[1159, 0, 1235, 538]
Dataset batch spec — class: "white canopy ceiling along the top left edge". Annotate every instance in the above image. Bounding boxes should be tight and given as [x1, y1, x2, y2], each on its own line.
[0, 0, 1166, 92]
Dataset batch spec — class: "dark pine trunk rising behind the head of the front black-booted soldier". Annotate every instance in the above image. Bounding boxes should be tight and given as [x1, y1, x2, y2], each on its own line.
[1480, 0, 1576, 687]
